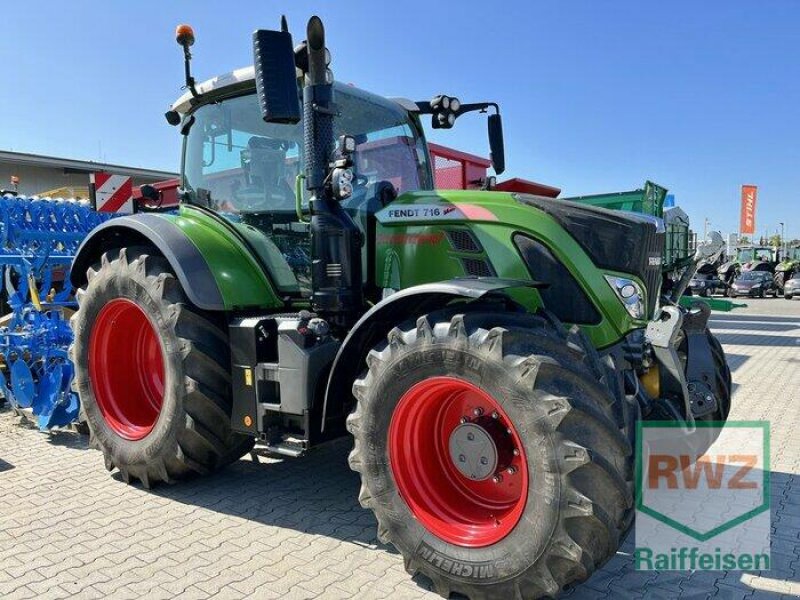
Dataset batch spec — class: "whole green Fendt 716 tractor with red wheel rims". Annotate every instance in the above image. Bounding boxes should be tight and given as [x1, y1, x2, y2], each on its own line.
[72, 17, 730, 598]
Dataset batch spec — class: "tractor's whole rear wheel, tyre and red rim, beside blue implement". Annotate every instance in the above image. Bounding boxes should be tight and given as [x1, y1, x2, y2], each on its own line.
[71, 248, 254, 487]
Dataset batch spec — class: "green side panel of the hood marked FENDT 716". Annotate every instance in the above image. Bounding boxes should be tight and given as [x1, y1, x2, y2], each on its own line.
[375, 190, 646, 348]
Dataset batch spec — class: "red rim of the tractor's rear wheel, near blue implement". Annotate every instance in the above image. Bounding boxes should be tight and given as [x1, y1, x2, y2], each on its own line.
[89, 298, 164, 440]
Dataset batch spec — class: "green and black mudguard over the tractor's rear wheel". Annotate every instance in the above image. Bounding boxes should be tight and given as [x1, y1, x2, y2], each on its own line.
[70, 207, 283, 311]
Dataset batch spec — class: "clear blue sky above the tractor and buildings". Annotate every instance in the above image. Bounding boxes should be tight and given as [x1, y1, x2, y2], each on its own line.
[0, 0, 800, 238]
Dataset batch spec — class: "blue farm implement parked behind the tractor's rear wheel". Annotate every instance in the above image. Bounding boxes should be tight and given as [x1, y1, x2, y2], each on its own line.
[0, 195, 116, 430]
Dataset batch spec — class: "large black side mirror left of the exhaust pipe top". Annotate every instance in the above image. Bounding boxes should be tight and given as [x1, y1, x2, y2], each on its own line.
[253, 17, 301, 124]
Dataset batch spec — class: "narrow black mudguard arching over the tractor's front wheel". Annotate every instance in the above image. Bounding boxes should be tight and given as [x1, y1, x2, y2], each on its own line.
[322, 277, 547, 430]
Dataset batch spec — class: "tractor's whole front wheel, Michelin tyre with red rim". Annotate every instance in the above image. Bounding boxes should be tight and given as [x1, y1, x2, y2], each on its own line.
[347, 313, 634, 599]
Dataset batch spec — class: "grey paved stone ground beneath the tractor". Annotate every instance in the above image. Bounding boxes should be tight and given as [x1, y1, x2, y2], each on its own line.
[0, 299, 800, 600]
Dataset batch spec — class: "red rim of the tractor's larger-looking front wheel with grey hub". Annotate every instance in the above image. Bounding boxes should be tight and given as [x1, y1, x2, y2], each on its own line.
[388, 377, 528, 547]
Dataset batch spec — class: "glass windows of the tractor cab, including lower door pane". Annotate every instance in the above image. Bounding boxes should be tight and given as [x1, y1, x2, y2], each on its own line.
[183, 85, 433, 295]
